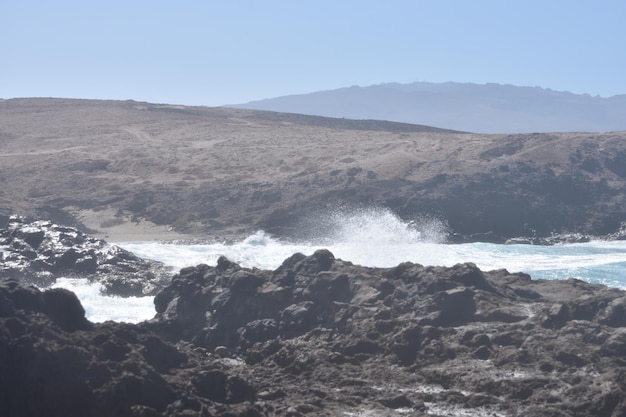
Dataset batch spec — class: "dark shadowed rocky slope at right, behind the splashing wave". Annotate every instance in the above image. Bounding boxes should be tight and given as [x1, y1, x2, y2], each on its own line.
[259, 153, 626, 244]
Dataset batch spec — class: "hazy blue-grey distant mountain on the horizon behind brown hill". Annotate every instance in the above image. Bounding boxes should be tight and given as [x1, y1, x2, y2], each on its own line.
[227, 82, 626, 133]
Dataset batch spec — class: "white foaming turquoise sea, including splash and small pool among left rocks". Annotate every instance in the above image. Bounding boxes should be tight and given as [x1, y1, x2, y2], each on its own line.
[54, 208, 626, 323]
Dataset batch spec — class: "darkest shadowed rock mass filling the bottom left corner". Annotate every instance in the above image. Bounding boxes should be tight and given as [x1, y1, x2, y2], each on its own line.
[0, 280, 262, 417]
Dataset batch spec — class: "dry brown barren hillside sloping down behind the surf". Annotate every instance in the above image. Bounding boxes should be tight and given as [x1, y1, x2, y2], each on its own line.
[0, 99, 626, 239]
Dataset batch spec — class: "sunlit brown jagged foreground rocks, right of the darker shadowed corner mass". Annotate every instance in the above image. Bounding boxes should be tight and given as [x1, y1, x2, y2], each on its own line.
[150, 250, 626, 416]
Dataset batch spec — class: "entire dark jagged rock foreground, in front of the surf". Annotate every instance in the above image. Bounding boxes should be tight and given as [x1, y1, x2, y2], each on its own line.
[0, 245, 626, 416]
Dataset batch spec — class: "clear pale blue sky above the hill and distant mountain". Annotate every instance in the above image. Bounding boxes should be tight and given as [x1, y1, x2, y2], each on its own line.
[0, 0, 626, 106]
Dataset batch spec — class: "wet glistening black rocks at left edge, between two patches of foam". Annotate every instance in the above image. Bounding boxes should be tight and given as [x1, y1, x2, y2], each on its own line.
[0, 216, 171, 296]
